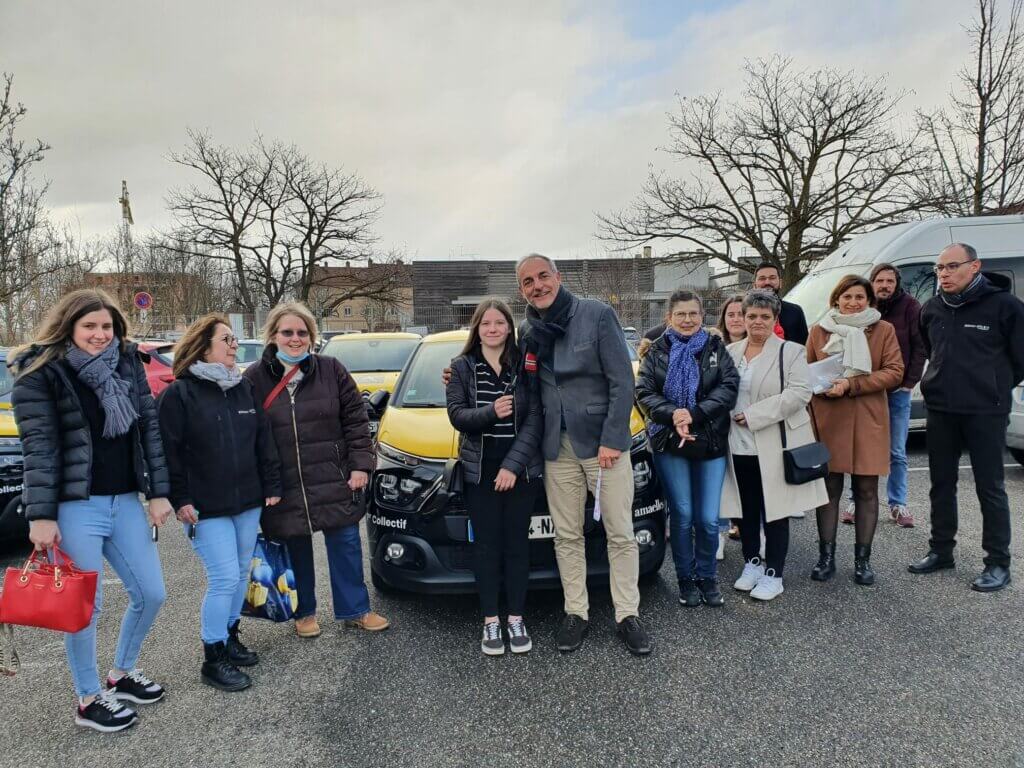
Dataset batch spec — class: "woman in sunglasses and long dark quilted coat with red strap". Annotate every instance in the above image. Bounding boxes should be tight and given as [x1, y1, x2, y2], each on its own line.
[245, 302, 389, 638]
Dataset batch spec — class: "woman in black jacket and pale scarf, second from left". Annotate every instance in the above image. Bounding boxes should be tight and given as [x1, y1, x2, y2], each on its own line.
[154, 314, 282, 691]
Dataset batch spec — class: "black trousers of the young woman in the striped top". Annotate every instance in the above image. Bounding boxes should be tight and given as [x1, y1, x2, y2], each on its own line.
[463, 464, 543, 616]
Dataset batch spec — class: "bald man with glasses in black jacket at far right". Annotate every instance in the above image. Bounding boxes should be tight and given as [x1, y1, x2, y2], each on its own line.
[909, 243, 1024, 592]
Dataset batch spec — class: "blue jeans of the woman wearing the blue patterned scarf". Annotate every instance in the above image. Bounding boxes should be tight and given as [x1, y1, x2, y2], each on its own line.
[654, 452, 726, 581]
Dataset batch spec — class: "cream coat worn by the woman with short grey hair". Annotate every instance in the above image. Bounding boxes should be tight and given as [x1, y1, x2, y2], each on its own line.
[721, 336, 828, 522]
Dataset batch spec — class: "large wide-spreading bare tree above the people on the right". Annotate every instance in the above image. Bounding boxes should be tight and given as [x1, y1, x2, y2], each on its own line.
[598, 56, 936, 289]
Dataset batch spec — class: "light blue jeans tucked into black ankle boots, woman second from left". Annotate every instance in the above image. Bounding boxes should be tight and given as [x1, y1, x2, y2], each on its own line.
[185, 507, 260, 643]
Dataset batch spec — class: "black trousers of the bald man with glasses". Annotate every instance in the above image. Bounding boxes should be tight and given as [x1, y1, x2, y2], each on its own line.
[928, 410, 1010, 567]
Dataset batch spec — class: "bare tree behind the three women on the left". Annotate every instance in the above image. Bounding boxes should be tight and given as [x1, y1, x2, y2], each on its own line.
[168, 131, 380, 312]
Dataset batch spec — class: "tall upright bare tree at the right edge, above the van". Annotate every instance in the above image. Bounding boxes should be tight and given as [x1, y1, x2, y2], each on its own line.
[918, 0, 1024, 216]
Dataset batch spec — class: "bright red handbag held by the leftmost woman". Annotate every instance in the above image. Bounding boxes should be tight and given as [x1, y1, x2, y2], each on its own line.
[0, 547, 98, 632]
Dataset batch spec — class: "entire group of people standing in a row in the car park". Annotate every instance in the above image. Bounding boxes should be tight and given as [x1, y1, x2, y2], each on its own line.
[10, 244, 1024, 731]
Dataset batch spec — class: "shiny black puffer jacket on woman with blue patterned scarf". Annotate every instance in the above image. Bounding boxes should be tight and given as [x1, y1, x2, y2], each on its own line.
[636, 334, 739, 459]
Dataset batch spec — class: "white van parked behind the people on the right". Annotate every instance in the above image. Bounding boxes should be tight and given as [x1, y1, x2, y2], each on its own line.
[785, 215, 1024, 429]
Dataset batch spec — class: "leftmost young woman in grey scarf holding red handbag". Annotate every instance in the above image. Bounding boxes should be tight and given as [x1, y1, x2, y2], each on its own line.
[9, 289, 172, 732]
